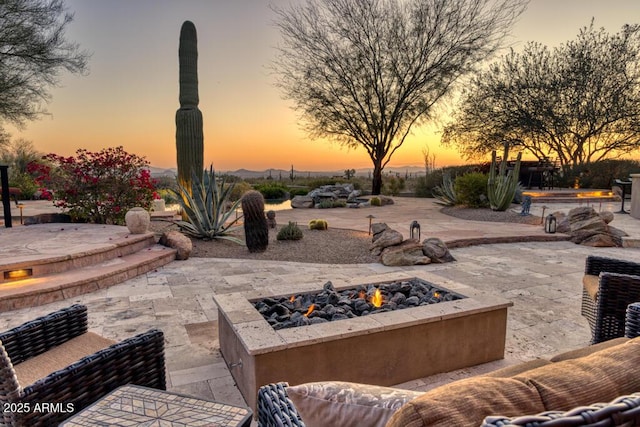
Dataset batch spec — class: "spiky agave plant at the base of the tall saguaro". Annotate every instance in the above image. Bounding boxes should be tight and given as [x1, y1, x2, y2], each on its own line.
[174, 166, 244, 245]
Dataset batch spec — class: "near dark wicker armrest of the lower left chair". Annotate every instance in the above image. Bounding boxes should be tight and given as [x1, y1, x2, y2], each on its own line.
[10, 329, 166, 426]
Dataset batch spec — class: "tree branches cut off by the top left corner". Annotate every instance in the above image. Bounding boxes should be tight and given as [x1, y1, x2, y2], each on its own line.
[0, 0, 89, 132]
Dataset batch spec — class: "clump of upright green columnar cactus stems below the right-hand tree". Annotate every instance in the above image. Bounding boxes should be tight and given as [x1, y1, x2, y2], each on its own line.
[487, 142, 522, 211]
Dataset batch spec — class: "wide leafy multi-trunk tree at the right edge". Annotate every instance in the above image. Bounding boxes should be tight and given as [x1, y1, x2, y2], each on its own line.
[442, 22, 640, 170]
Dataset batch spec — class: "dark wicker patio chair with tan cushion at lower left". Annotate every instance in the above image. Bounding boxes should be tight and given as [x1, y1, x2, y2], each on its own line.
[0, 304, 166, 427]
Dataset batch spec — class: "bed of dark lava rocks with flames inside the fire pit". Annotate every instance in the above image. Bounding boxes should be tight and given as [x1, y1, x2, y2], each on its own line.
[253, 277, 466, 330]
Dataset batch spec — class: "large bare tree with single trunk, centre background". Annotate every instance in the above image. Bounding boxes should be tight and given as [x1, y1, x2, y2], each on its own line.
[274, 0, 526, 194]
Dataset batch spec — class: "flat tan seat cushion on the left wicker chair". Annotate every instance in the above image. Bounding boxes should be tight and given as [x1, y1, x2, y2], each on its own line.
[13, 332, 116, 387]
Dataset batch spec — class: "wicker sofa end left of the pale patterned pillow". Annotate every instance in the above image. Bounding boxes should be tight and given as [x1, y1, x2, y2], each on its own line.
[257, 382, 305, 427]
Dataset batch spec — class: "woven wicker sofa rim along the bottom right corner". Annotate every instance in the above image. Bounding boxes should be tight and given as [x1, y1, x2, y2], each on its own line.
[482, 393, 640, 427]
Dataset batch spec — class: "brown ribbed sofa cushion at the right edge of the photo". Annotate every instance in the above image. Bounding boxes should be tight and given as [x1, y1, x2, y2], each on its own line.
[512, 337, 640, 416]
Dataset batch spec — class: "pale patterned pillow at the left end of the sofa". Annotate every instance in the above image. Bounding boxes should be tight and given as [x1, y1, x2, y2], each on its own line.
[287, 381, 422, 427]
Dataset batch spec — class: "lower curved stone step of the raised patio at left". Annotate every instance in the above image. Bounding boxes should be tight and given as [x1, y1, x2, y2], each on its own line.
[0, 243, 175, 312]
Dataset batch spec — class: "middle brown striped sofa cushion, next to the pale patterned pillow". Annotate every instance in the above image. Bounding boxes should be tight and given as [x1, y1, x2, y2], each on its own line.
[387, 377, 544, 427]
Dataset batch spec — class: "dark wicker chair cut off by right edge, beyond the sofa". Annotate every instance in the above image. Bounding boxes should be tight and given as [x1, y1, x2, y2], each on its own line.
[581, 256, 640, 344]
